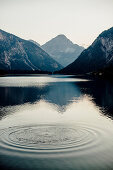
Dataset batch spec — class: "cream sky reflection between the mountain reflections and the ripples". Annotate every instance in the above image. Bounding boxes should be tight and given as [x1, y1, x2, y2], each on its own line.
[0, 96, 104, 126]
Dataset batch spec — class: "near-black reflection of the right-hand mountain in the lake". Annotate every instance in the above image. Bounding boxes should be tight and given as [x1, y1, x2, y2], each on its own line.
[77, 81, 113, 117]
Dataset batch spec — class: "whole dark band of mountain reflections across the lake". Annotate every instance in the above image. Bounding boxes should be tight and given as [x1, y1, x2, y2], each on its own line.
[0, 77, 113, 119]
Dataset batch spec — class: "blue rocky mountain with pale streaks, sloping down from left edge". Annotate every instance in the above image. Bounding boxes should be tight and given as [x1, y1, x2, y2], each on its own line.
[0, 30, 62, 72]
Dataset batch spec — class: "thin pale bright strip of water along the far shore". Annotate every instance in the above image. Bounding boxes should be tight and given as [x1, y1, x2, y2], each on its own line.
[0, 76, 88, 87]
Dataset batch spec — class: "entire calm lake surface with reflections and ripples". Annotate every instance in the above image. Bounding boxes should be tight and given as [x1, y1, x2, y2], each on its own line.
[0, 75, 113, 170]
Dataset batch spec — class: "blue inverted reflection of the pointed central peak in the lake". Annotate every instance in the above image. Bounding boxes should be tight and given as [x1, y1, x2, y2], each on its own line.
[45, 82, 81, 112]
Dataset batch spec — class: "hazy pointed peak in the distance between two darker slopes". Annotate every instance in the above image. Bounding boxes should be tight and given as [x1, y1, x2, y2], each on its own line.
[42, 34, 84, 67]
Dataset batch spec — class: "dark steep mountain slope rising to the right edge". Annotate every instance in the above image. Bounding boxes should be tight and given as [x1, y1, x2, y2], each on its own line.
[59, 27, 113, 74]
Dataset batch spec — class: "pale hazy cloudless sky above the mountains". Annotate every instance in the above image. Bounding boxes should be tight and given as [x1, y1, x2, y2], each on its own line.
[0, 0, 113, 45]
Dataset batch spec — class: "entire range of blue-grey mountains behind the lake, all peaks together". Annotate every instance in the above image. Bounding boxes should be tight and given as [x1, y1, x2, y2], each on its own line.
[0, 27, 113, 75]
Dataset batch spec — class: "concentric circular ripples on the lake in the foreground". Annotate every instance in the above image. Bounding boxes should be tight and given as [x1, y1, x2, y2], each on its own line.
[0, 123, 108, 157]
